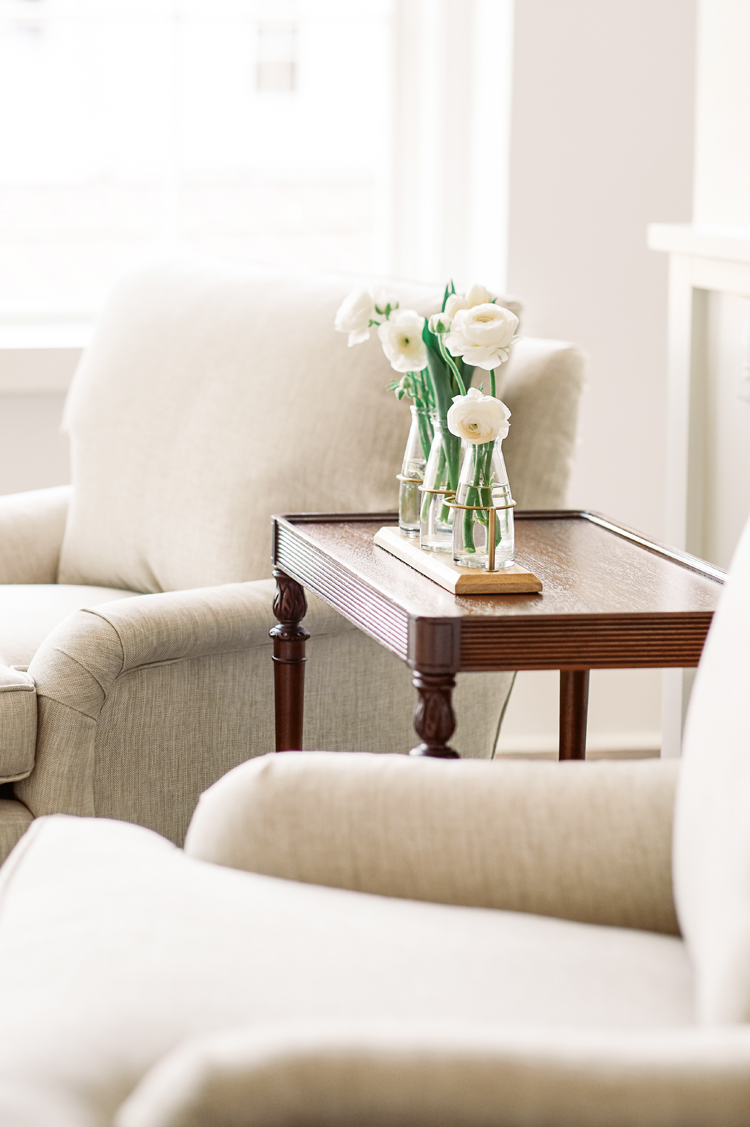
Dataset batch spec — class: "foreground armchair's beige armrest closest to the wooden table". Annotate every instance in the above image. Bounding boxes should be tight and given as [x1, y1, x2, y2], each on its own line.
[185, 752, 678, 934]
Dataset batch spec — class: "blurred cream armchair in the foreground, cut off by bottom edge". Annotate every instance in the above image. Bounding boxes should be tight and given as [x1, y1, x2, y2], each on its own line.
[0, 516, 750, 1127]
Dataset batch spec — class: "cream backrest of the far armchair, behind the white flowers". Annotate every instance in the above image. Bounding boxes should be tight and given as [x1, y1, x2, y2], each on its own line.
[59, 263, 581, 592]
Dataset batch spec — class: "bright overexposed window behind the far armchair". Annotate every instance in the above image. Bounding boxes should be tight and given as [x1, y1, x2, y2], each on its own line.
[0, 0, 392, 320]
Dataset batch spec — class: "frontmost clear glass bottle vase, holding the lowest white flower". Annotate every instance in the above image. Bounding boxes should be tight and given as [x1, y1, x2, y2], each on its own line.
[453, 438, 514, 571]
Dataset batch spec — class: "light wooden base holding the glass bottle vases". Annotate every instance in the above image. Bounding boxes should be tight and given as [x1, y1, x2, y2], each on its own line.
[373, 527, 541, 595]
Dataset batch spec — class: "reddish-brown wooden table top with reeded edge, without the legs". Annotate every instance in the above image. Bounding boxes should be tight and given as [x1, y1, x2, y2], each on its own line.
[274, 511, 725, 669]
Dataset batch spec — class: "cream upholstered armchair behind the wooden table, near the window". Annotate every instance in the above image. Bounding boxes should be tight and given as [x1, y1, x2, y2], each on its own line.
[0, 263, 582, 860]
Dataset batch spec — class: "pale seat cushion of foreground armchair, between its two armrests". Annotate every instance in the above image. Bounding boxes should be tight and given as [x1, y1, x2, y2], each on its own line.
[0, 815, 691, 1127]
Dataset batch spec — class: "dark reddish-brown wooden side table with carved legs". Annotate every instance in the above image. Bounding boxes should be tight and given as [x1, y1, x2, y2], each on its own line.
[271, 511, 725, 758]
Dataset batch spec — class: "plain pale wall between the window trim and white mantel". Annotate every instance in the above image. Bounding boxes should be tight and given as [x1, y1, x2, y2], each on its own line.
[503, 0, 694, 749]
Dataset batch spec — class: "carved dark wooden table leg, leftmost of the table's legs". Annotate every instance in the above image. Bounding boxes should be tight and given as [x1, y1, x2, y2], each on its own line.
[270, 568, 310, 752]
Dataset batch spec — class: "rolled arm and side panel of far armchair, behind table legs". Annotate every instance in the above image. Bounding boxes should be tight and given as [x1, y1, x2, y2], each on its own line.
[16, 580, 512, 843]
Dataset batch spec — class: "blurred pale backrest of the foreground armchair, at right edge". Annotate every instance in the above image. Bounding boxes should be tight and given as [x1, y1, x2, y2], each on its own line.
[674, 523, 750, 1023]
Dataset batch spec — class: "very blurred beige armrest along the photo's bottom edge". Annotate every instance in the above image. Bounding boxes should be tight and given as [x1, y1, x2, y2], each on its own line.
[115, 1021, 750, 1127]
